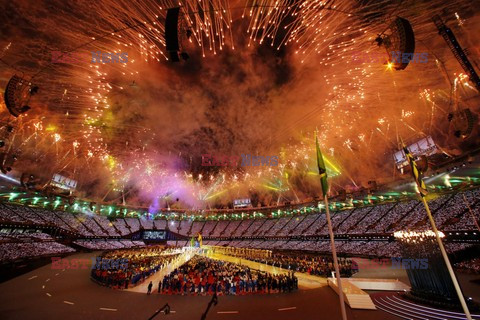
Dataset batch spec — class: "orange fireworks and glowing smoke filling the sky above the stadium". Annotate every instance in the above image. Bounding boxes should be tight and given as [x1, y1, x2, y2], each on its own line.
[0, 0, 475, 207]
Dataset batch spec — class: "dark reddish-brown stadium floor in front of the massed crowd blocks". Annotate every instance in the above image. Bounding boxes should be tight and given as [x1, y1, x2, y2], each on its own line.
[0, 253, 399, 320]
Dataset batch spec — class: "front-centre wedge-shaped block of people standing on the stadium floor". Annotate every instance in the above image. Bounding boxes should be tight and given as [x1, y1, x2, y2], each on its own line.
[158, 256, 298, 295]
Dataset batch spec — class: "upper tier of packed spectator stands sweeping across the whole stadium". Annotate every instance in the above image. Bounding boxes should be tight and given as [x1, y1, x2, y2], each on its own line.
[0, 189, 480, 237]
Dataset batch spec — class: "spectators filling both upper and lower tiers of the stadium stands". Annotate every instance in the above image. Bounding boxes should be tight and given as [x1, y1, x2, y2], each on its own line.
[0, 189, 480, 261]
